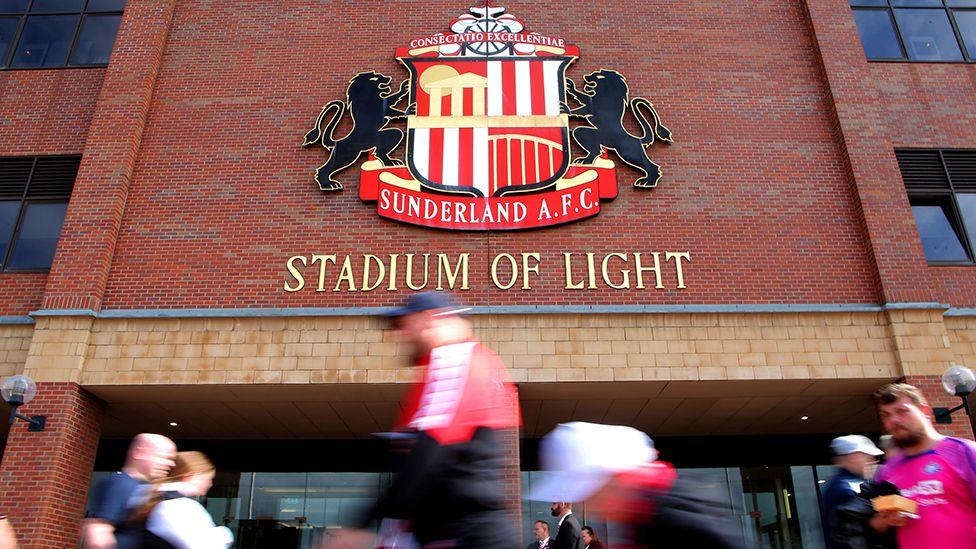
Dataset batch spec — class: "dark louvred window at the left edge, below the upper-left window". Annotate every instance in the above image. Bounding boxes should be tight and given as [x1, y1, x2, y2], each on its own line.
[0, 156, 81, 271]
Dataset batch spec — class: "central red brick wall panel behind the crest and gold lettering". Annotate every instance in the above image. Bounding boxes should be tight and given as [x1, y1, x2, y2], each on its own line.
[87, 0, 878, 308]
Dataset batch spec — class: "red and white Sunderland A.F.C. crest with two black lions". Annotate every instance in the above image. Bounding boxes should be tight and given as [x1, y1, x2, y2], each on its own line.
[303, 1, 671, 231]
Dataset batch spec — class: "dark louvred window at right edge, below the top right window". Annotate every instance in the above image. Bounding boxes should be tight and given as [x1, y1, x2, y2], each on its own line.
[895, 149, 976, 264]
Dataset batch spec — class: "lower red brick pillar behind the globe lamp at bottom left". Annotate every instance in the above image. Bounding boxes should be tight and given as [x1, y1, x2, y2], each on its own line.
[0, 383, 104, 549]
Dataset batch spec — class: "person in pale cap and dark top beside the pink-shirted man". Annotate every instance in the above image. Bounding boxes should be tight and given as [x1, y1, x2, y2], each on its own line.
[823, 435, 884, 549]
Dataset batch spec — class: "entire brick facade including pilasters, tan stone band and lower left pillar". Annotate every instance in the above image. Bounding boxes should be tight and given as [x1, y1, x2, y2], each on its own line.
[0, 0, 976, 547]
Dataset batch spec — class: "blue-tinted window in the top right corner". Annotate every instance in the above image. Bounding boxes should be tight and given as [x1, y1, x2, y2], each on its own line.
[850, 0, 976, 62]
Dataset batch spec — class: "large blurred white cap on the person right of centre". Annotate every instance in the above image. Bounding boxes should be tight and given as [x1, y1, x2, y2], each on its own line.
[528, 421, 657, 502]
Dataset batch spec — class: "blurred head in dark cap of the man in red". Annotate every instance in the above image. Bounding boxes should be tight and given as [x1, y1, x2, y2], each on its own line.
[390, 292, 471, 355]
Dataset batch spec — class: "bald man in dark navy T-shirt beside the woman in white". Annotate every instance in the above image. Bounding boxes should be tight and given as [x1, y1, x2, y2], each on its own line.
[82, 433, 176, 549]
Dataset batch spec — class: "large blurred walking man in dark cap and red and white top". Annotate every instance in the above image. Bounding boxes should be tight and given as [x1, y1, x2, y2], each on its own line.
[330, 292, 520, 549]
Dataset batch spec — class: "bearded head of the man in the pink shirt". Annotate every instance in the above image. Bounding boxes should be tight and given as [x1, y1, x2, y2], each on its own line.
[874, 383, 935, 448]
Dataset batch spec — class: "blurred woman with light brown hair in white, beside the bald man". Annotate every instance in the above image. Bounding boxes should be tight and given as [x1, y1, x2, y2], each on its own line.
[136, 452, 234, 549]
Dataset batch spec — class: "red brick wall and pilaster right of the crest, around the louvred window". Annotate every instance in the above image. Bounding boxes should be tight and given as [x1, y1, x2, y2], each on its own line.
[806, 0, 976, 307]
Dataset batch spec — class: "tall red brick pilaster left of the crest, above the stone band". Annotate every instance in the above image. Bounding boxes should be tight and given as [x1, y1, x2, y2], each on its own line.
[41, 0, 175, 310]
